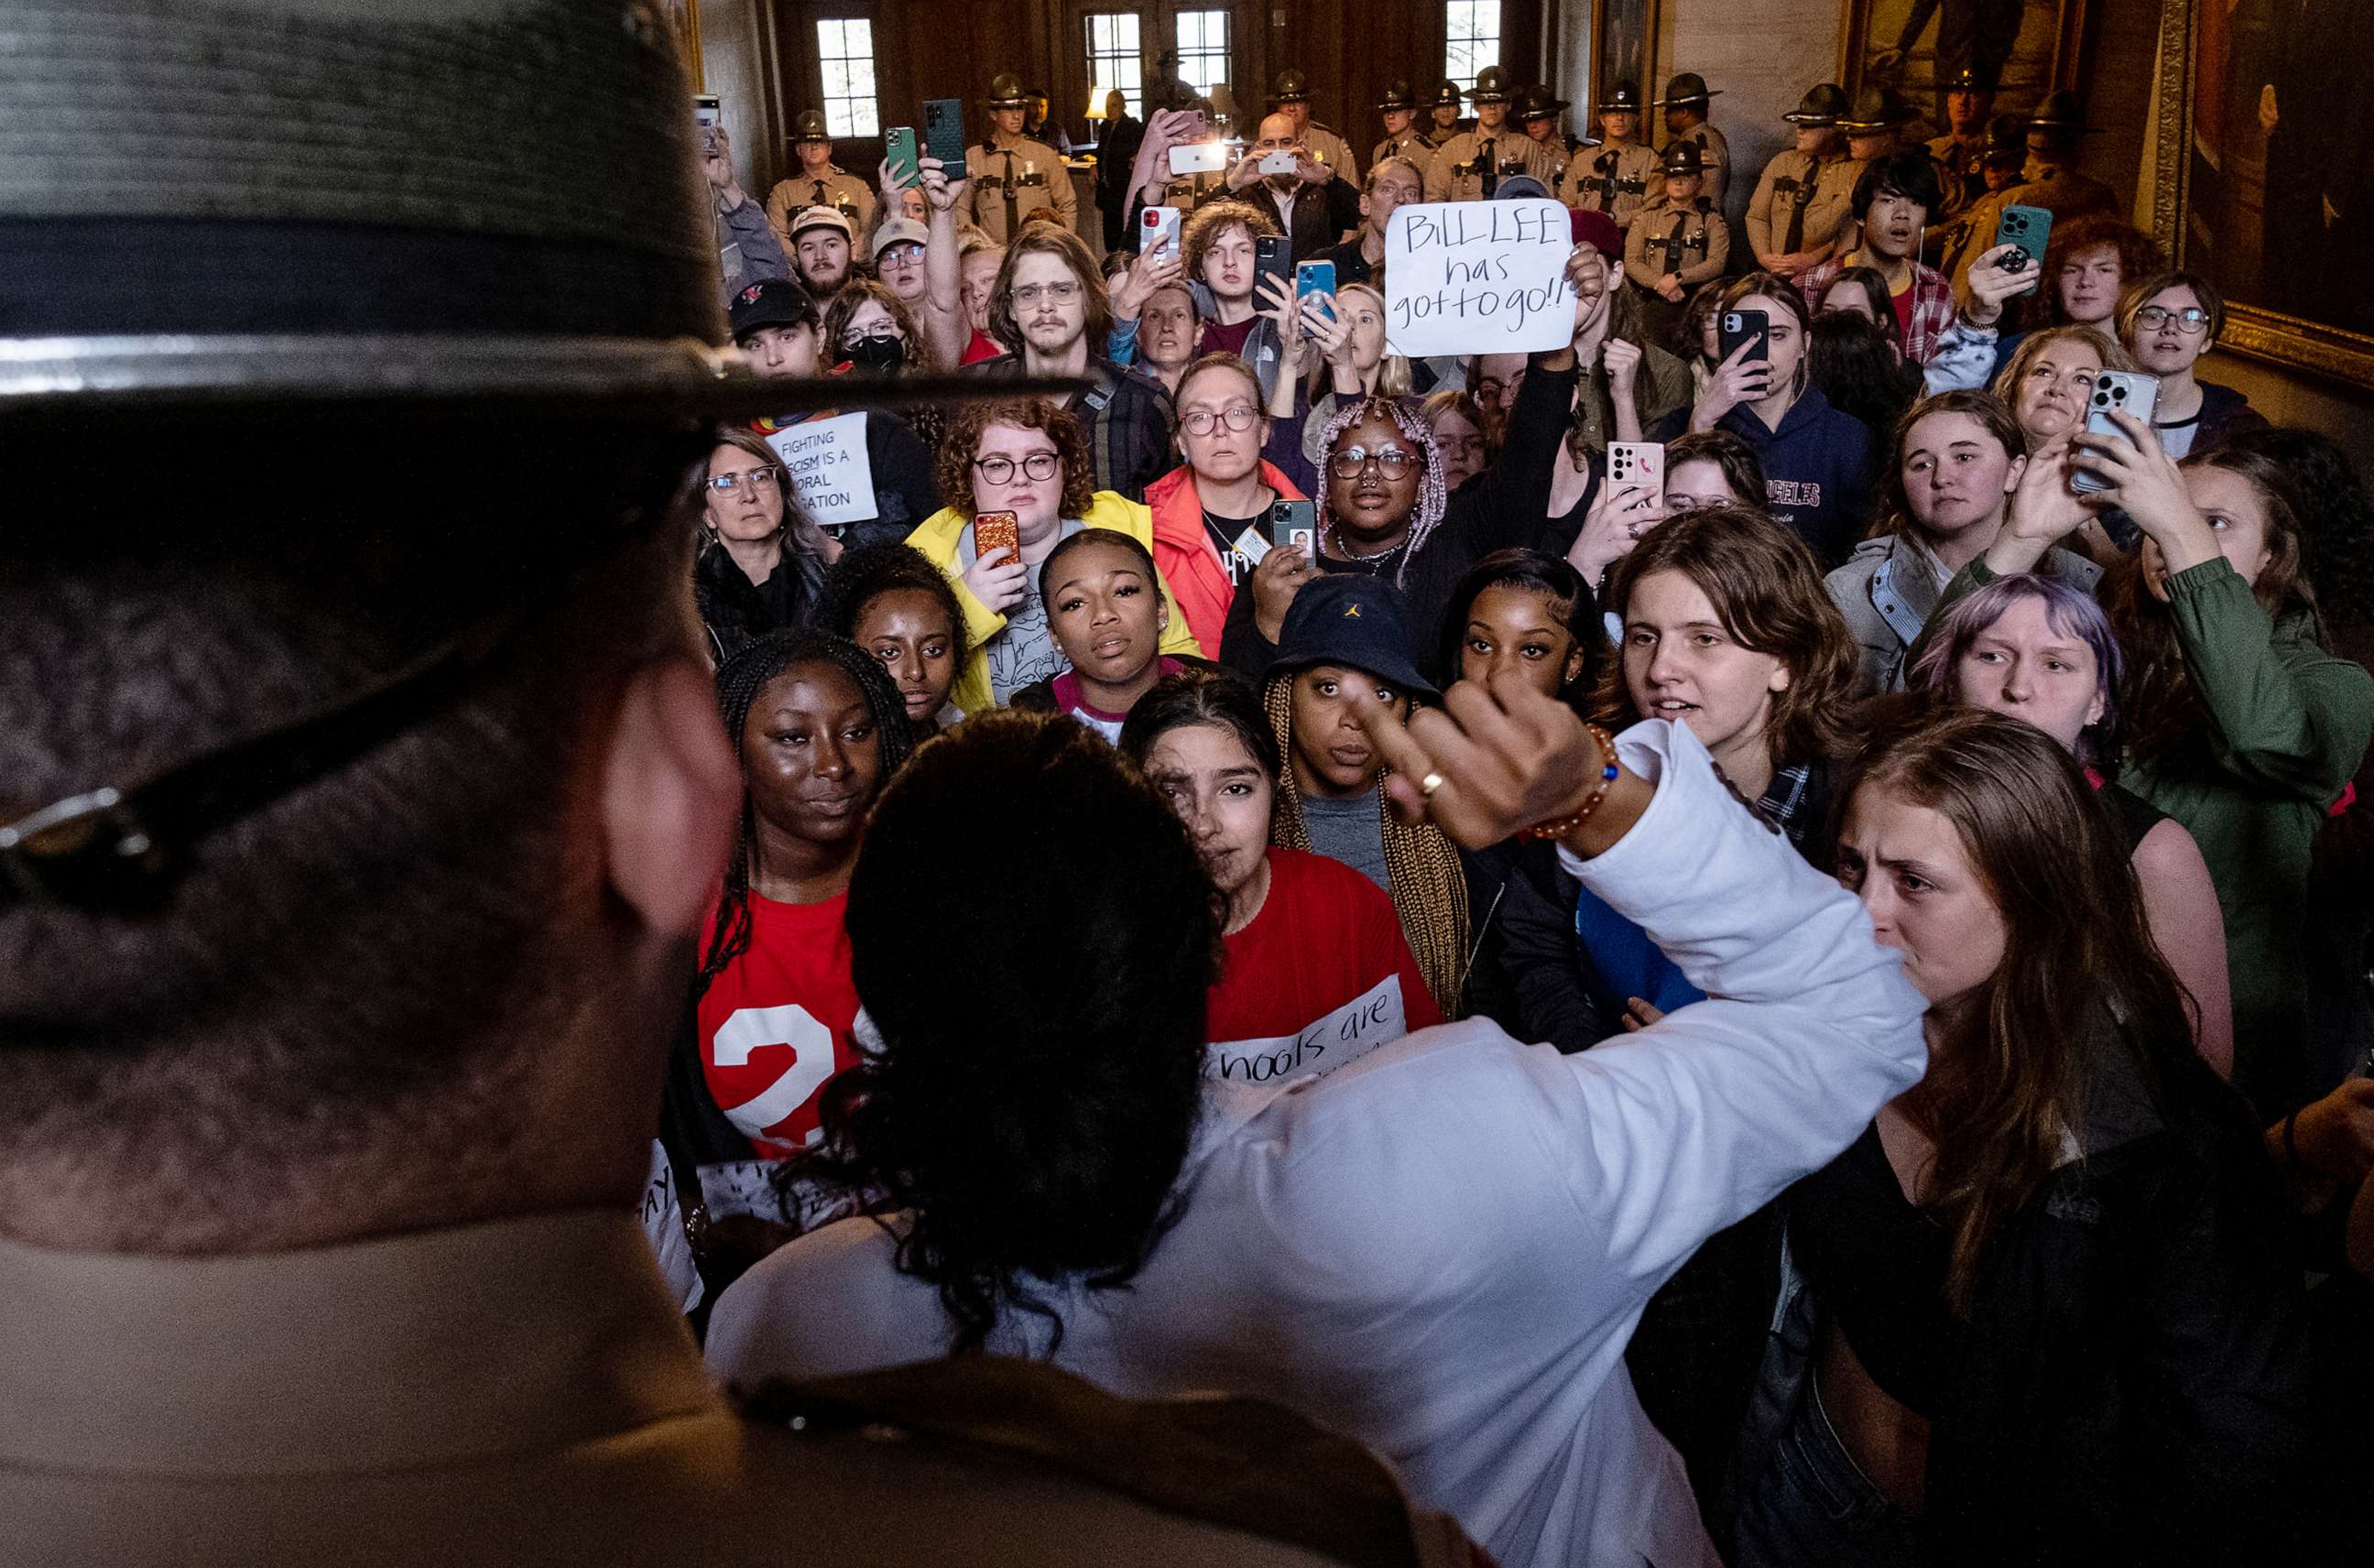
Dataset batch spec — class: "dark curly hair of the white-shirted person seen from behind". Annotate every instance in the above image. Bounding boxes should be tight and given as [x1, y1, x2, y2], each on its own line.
[798, 711, 1225, 1355]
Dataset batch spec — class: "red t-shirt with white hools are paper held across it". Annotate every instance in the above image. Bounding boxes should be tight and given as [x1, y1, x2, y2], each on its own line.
[1203, 845, 1443, 1083]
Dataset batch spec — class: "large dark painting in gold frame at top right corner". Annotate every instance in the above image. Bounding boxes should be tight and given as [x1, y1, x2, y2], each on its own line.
[2153, 0, 2374, 387]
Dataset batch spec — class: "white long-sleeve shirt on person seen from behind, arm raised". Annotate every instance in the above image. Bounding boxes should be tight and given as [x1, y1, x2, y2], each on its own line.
[707, 720, 1925, 1568]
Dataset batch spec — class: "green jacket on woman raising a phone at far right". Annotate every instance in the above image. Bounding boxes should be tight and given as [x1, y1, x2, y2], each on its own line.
[1940, 561, 2374, 1115]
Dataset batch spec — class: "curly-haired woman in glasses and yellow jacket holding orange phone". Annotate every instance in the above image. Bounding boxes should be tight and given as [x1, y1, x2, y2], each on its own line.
[907, 397, 1196, 713]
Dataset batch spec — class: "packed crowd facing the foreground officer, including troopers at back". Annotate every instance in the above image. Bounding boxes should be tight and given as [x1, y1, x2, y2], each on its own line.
[665, 60, 2374, 1565]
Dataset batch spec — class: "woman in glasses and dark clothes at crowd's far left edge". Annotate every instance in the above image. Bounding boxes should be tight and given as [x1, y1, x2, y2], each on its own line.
[693, 430, 841, 663]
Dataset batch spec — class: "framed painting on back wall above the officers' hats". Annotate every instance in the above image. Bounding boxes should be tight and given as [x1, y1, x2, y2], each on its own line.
[1837, 0, 2086, 124]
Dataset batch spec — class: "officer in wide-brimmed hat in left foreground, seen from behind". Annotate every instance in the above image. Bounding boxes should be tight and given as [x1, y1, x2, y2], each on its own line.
[0, 0, 1475, 1568]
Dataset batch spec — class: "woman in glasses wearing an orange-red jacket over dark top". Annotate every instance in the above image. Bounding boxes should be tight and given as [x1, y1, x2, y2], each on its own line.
[1147, 354, 1303, 659]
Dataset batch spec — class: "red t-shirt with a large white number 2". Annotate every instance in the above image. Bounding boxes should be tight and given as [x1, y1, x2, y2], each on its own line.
[698, 893, 857, 1160]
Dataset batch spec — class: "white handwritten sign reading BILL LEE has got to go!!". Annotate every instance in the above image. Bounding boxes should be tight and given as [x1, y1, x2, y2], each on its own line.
[1384, 200, 1574, 359]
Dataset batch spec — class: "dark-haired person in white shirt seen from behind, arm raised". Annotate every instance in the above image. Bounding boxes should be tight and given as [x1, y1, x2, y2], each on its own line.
[710, 680, 1923, 1568]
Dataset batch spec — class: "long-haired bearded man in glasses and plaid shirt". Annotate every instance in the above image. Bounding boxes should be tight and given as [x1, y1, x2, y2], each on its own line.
[964, 223, 1172, 501]
